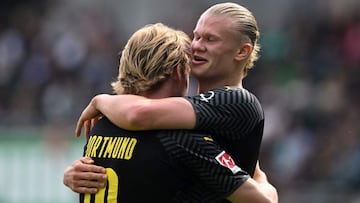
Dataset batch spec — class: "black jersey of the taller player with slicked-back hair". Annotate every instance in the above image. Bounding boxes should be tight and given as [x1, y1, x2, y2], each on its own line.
[186, 87, 264, 176]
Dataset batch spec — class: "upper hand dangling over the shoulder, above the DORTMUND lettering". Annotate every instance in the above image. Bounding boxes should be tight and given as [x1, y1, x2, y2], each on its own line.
[75, 96, 103, 139]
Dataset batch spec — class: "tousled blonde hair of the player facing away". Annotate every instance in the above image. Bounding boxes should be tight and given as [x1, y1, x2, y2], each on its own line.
[111, 23, 191, 94]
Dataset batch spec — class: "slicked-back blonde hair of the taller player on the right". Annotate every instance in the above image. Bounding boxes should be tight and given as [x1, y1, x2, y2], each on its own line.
[201, 2, 260, 77]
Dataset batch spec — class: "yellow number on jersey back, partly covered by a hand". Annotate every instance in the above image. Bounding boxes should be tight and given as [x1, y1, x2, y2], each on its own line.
[84, 168, 119, 203]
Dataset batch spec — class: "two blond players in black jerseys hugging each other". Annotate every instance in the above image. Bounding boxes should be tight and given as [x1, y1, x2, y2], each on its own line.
[63, 3, 278, 203]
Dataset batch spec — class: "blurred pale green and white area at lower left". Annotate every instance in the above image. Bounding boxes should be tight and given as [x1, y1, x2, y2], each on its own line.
[0, 127, 85, 203]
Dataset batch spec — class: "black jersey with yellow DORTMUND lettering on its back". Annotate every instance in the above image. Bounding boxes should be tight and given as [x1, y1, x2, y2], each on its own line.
[80, 118, 249, 203]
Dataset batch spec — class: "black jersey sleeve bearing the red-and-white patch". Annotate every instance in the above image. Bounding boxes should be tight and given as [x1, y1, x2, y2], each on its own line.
[160, 130, 249, 202]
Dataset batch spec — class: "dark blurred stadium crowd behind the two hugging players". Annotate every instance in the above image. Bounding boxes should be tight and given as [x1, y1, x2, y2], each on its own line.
[0, 0, 360, 202]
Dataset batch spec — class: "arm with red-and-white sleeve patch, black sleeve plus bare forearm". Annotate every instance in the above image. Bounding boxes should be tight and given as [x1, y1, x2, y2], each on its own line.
[160, 131, 277, 203]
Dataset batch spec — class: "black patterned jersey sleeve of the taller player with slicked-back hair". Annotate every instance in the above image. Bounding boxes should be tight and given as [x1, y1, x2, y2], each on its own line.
[185, 88, 264, 139]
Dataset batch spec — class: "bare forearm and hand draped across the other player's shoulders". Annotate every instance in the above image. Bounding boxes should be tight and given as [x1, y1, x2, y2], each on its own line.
[75, 94, 196, 136]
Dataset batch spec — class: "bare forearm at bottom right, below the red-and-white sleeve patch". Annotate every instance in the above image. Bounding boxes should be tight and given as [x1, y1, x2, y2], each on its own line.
[227, 163, 279, 203]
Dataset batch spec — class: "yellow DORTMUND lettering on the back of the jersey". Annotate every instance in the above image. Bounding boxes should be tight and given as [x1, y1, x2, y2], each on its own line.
[85, 135, 137, 160]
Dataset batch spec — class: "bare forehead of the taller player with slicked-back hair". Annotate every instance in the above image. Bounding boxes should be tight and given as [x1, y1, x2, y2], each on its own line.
[194, 15, 234, 36]
